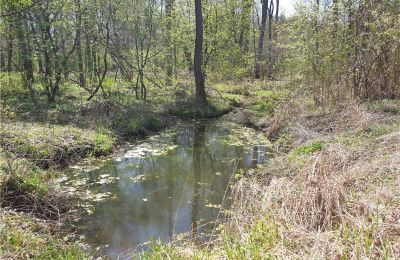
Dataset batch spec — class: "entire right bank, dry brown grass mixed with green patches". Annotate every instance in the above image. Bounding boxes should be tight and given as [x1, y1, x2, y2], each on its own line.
[141, 95, 400, 259]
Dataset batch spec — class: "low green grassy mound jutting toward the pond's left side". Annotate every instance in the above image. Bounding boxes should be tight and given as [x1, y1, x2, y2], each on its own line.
[0, 122, 114, 168]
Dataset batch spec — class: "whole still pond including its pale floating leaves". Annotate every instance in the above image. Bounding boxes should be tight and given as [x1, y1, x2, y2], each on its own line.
[67, 121, 268, 258]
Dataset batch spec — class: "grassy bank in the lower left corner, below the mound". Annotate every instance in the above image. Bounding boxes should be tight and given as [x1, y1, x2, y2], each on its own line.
[0, 150, 88, 259]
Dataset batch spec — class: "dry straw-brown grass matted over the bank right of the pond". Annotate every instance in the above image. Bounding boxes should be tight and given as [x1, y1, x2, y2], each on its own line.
[225, 102, 400, 259]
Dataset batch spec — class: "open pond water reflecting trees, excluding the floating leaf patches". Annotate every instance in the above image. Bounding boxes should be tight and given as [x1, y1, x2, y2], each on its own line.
[79, 123, 265, 254]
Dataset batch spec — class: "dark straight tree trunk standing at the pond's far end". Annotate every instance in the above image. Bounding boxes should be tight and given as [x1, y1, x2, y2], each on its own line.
[194, 0, 207, 105]
